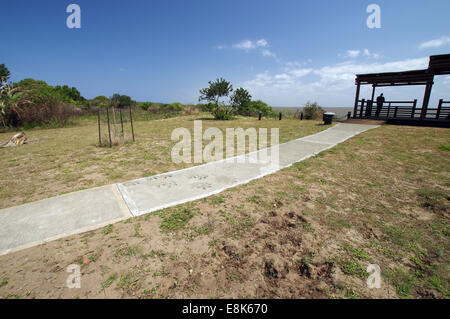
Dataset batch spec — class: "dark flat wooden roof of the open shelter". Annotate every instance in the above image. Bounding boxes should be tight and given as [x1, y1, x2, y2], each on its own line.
[356, 54, 450, 86]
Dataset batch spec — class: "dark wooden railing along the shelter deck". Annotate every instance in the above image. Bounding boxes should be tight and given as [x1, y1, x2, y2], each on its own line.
[354, 99, 450, 120]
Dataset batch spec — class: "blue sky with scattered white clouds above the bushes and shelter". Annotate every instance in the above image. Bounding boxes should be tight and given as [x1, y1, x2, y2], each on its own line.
[0, 0, 450, 106]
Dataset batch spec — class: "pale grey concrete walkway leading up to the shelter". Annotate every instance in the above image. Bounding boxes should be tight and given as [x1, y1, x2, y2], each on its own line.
[0, 123, 377, 255]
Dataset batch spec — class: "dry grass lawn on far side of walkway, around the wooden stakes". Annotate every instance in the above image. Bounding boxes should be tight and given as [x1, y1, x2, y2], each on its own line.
[0, 114, 329, 208]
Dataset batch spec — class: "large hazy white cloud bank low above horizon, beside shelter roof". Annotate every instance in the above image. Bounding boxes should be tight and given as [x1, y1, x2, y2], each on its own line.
[242, 57, 430, 106]
